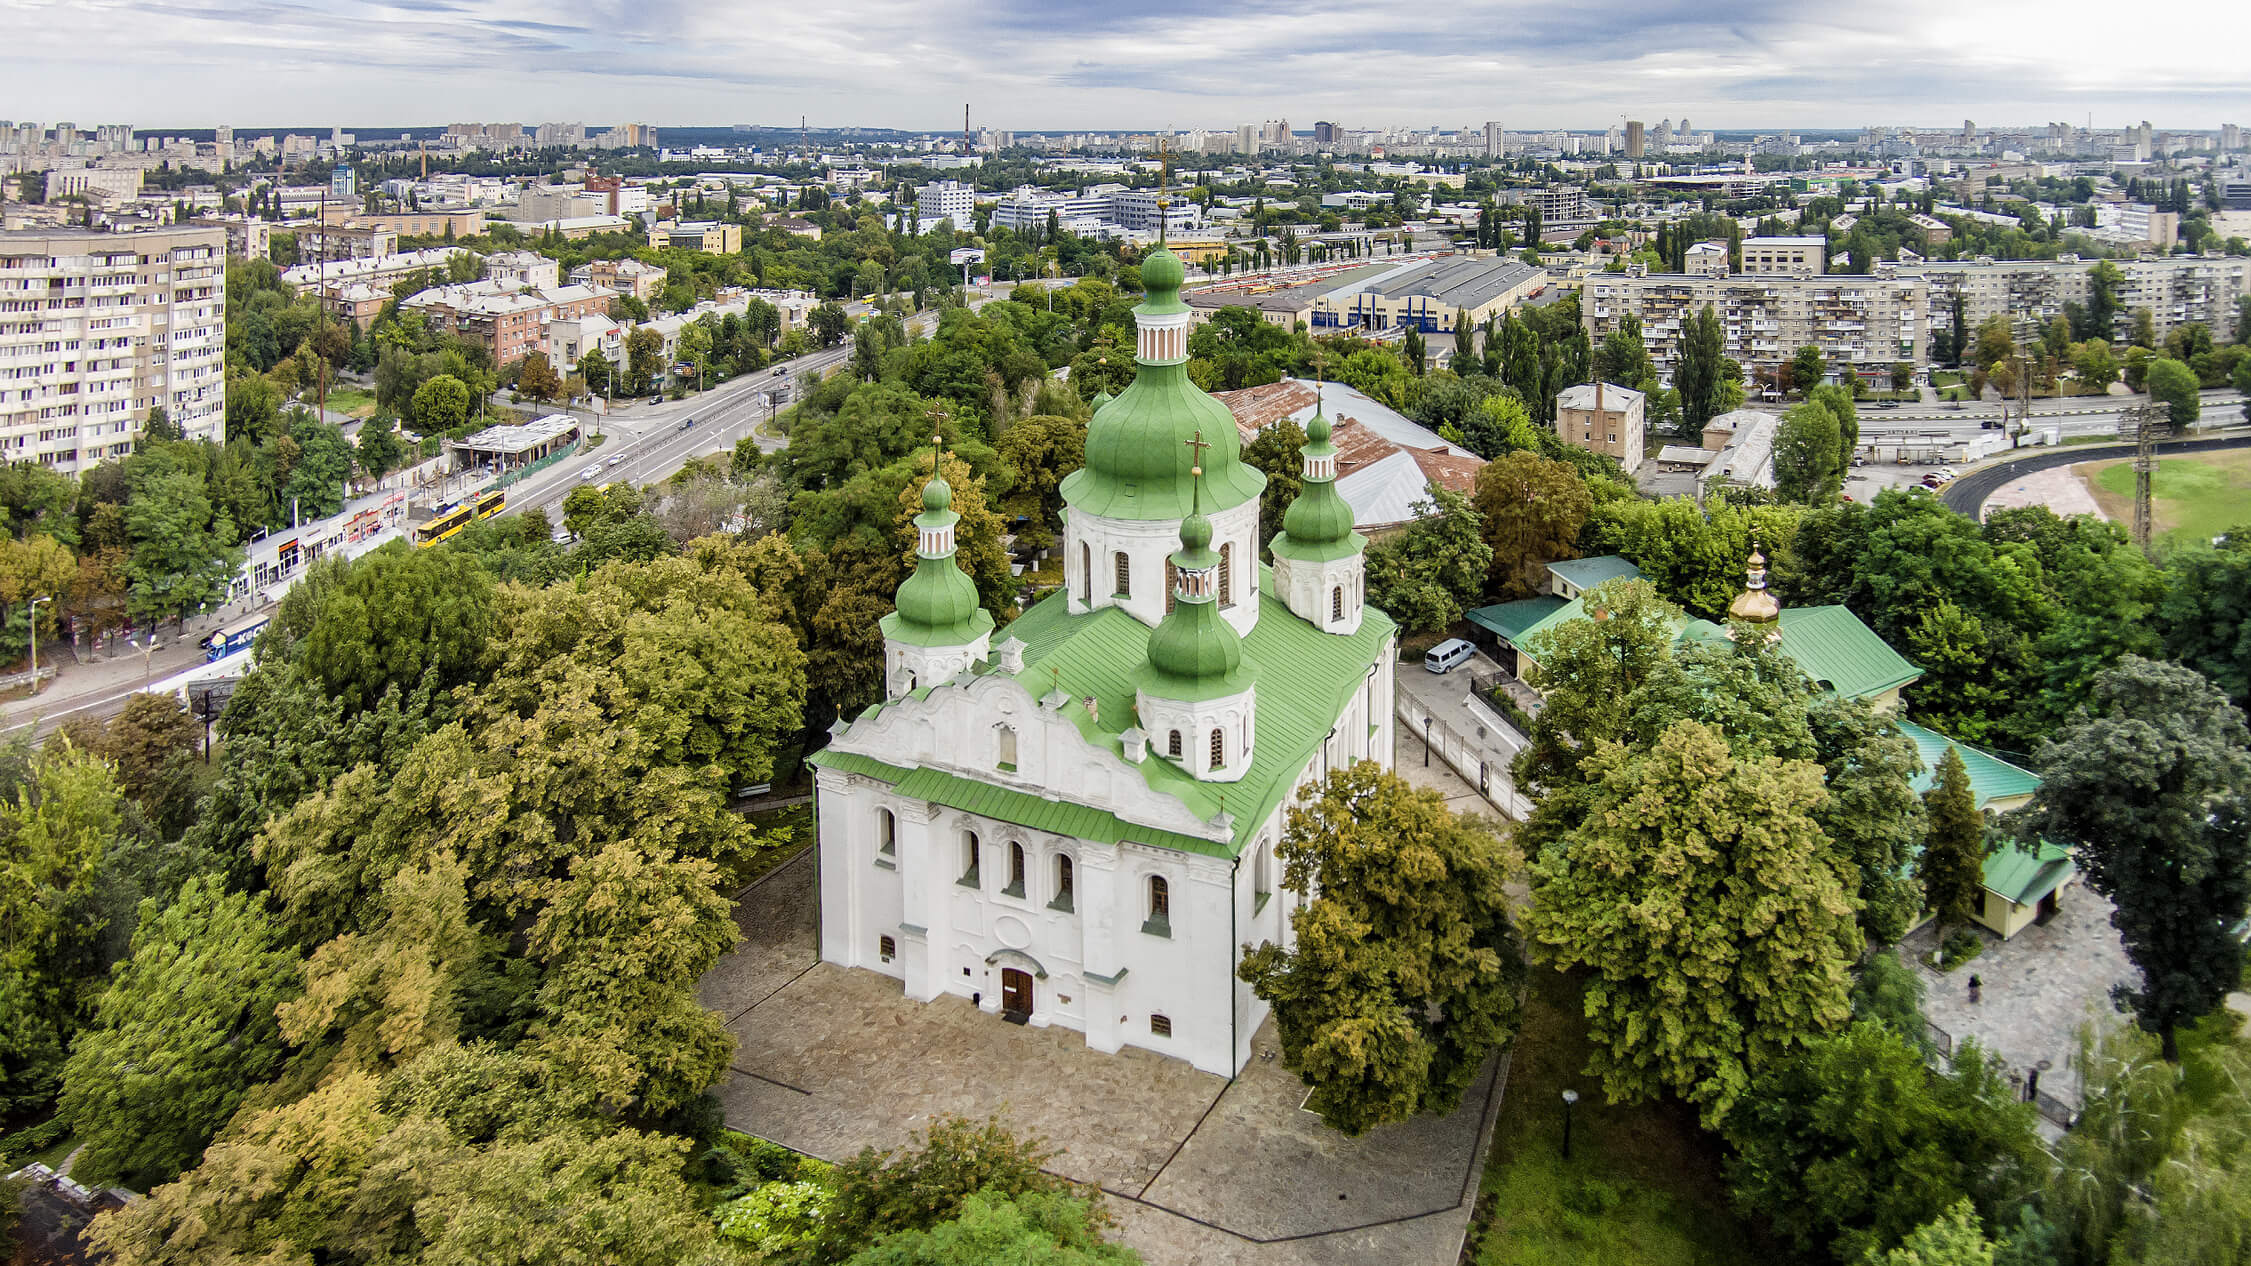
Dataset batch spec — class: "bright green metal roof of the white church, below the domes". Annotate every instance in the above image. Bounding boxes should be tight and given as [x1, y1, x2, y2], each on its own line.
[808, 568, 1393, 856]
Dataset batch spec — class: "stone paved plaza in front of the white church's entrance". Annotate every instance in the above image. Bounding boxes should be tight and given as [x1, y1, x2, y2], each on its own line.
[702, 824, 1506, 1266]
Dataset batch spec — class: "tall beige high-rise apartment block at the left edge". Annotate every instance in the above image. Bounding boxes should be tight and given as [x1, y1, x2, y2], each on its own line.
[0, 225, 227, 473]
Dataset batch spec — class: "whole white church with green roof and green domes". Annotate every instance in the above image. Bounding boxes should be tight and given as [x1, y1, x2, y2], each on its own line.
[810, 234, 1398, 1075]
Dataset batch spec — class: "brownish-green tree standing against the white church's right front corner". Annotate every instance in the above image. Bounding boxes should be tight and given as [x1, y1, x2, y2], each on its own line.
[1238, 761, 1524, 1135]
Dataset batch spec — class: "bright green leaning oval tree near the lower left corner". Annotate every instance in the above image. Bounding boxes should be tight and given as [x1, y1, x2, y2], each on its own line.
[61, 876, 299, 1189]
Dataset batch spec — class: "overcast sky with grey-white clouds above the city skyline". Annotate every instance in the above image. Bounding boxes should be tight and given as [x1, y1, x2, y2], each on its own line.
[0, 0, 2251, 131]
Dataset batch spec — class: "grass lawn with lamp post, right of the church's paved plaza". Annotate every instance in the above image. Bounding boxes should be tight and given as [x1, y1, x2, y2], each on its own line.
[1470, 966, 1767, 1266]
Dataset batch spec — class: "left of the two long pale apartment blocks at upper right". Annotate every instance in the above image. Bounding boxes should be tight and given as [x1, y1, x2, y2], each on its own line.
[1580, 268, 1931, 378]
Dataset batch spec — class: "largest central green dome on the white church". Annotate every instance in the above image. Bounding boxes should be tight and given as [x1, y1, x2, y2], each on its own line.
[1062, 365, 1265, 520]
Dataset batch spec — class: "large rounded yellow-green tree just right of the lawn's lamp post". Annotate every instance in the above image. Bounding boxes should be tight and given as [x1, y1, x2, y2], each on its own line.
[1524, 721, 1857, 1124]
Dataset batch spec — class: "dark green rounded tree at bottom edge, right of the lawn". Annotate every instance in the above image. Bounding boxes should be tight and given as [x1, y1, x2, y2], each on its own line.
[1724, 1023, 2044, 1264]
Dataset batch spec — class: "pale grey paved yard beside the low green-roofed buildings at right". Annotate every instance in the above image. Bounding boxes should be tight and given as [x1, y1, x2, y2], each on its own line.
[1900, 883, 2141, 1104]
